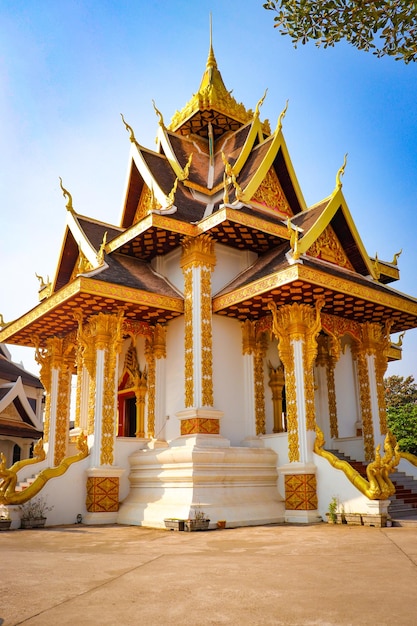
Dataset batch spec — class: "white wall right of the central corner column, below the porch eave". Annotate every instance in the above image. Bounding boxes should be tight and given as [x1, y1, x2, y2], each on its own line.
[213, 315, 245, 446]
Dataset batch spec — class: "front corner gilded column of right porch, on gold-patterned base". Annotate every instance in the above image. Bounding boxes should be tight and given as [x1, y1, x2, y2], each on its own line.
[269, 299, 324, 522]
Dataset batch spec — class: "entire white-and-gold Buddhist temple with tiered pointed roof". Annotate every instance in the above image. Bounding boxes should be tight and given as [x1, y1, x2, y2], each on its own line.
[0, 31, 417, 528]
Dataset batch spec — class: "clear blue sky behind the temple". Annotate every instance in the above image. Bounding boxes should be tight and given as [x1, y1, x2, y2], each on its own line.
[0, 0, 417, 379]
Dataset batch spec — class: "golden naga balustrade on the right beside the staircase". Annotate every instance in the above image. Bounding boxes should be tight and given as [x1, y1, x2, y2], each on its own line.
[314, 426, 400, 500]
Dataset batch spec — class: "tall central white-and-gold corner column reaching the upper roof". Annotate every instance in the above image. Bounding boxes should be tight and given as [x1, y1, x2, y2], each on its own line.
[178, 235, 219, 435]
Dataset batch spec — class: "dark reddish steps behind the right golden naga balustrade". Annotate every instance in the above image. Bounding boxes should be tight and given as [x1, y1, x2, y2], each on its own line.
[329, 450, 417, 527]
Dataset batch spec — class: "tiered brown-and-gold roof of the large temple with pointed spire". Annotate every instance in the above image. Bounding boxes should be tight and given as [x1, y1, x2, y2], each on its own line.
[0, 44, 417, 345]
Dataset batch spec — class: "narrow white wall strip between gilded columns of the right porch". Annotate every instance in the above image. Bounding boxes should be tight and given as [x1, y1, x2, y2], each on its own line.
[334, 343, 358, 439]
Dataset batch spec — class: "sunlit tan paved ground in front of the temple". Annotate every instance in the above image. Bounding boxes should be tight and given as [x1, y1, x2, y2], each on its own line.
[0, 524, 417, 626]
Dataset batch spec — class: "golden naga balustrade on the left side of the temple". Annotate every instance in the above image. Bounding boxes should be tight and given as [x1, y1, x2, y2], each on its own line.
[0, 433, 88, 504]
